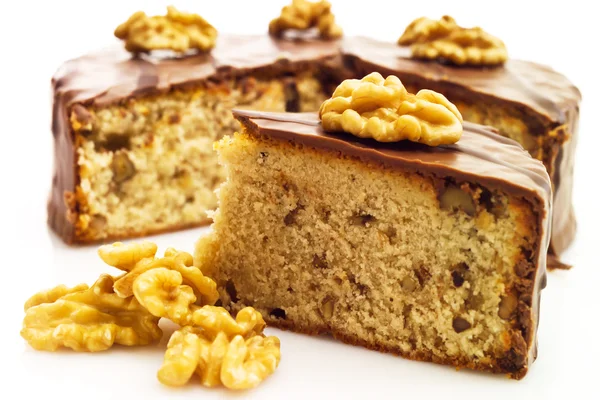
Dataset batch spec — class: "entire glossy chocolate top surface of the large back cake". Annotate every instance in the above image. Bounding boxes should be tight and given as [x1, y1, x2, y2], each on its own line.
[53, 34, 581, 124]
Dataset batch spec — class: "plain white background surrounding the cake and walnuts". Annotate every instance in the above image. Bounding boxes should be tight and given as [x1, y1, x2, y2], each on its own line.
[0, 0, 600, 399]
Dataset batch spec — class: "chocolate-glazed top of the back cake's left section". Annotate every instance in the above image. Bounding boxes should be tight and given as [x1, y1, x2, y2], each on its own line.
[52, 35, 339, 106]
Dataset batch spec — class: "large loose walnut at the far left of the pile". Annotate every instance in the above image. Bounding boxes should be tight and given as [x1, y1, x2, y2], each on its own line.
[21, 275, 162, 352]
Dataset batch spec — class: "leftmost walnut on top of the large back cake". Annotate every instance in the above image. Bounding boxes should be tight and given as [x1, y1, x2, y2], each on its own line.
[115, 6, 217, 53]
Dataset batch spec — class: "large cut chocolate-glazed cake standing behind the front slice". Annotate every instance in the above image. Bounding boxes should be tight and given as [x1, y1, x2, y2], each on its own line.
[49, 9, 580, 265]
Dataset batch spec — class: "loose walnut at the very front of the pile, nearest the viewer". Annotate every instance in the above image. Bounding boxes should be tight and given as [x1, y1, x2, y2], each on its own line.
[158, 327, 281, 390]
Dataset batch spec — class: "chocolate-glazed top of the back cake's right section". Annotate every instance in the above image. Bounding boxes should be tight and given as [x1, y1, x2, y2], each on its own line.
[342, 37, 581, 124]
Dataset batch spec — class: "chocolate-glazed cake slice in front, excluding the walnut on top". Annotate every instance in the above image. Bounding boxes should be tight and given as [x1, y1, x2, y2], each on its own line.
[195, 111, 551, 379]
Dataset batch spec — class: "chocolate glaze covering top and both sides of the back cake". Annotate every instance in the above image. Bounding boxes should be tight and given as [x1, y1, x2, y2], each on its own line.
[49, 35, 581, 255]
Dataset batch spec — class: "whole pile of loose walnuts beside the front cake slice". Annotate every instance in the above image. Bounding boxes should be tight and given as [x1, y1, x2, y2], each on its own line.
[21, 242, 281, 390]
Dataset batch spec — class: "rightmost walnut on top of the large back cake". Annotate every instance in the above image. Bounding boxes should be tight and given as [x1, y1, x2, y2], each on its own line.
[398, 15, 508, 66]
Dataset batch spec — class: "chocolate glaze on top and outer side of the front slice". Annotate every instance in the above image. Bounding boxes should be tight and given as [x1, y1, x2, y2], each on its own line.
[233, 110, 552, 377]
